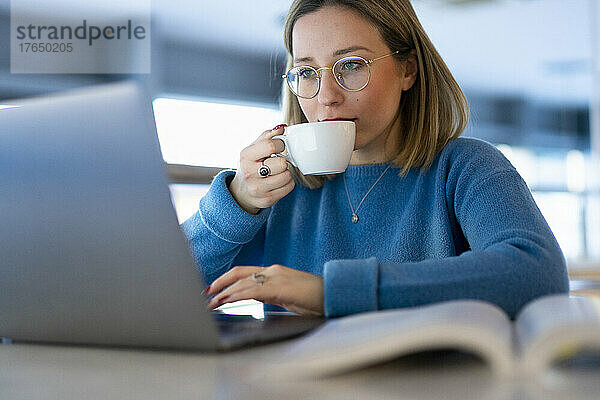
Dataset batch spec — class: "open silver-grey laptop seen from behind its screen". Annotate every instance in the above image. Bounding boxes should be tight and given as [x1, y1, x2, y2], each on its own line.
[0, 83, 323, 350]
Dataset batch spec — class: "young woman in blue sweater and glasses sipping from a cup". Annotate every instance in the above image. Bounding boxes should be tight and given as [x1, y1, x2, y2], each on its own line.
[183, 0, 568, 317]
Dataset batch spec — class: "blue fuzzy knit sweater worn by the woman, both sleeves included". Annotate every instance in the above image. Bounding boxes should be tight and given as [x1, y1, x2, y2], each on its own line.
[182, 138, 568, 317]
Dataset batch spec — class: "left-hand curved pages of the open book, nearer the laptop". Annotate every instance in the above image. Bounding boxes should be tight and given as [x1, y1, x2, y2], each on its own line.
[264, 300, 513, 376]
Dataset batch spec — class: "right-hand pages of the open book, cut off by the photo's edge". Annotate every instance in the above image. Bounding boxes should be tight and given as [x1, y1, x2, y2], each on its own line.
[515, 294, 600, 374]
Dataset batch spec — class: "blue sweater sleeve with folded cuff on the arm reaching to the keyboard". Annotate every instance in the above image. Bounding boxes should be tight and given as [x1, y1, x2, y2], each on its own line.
[323, 144, 569, 318]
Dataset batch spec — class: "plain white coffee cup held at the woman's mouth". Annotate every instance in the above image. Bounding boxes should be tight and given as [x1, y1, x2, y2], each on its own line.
[273, 121, 356, 175]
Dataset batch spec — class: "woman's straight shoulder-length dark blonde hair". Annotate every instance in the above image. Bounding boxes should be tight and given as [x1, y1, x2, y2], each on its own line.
[282, 0, 469, 189]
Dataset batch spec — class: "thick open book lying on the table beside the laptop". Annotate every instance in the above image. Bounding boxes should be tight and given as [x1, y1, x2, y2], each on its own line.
[264, 295, 600, 376]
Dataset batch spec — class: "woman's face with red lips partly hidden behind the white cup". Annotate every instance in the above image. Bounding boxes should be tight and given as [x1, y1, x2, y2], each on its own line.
[292, 6, 414, 164]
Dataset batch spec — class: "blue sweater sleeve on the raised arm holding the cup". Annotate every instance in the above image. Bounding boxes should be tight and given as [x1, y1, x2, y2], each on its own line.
[181, 170, 270, 284]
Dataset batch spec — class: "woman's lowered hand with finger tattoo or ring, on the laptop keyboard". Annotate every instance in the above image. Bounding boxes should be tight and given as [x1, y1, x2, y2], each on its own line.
[204, 264, 323, 316]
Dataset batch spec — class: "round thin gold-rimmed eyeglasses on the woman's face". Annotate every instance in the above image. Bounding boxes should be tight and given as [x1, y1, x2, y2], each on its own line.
[281, 50, 399, 99]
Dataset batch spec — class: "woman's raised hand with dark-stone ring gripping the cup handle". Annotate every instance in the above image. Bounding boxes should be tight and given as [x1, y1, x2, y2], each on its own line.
[229, 125, 294, 214]
